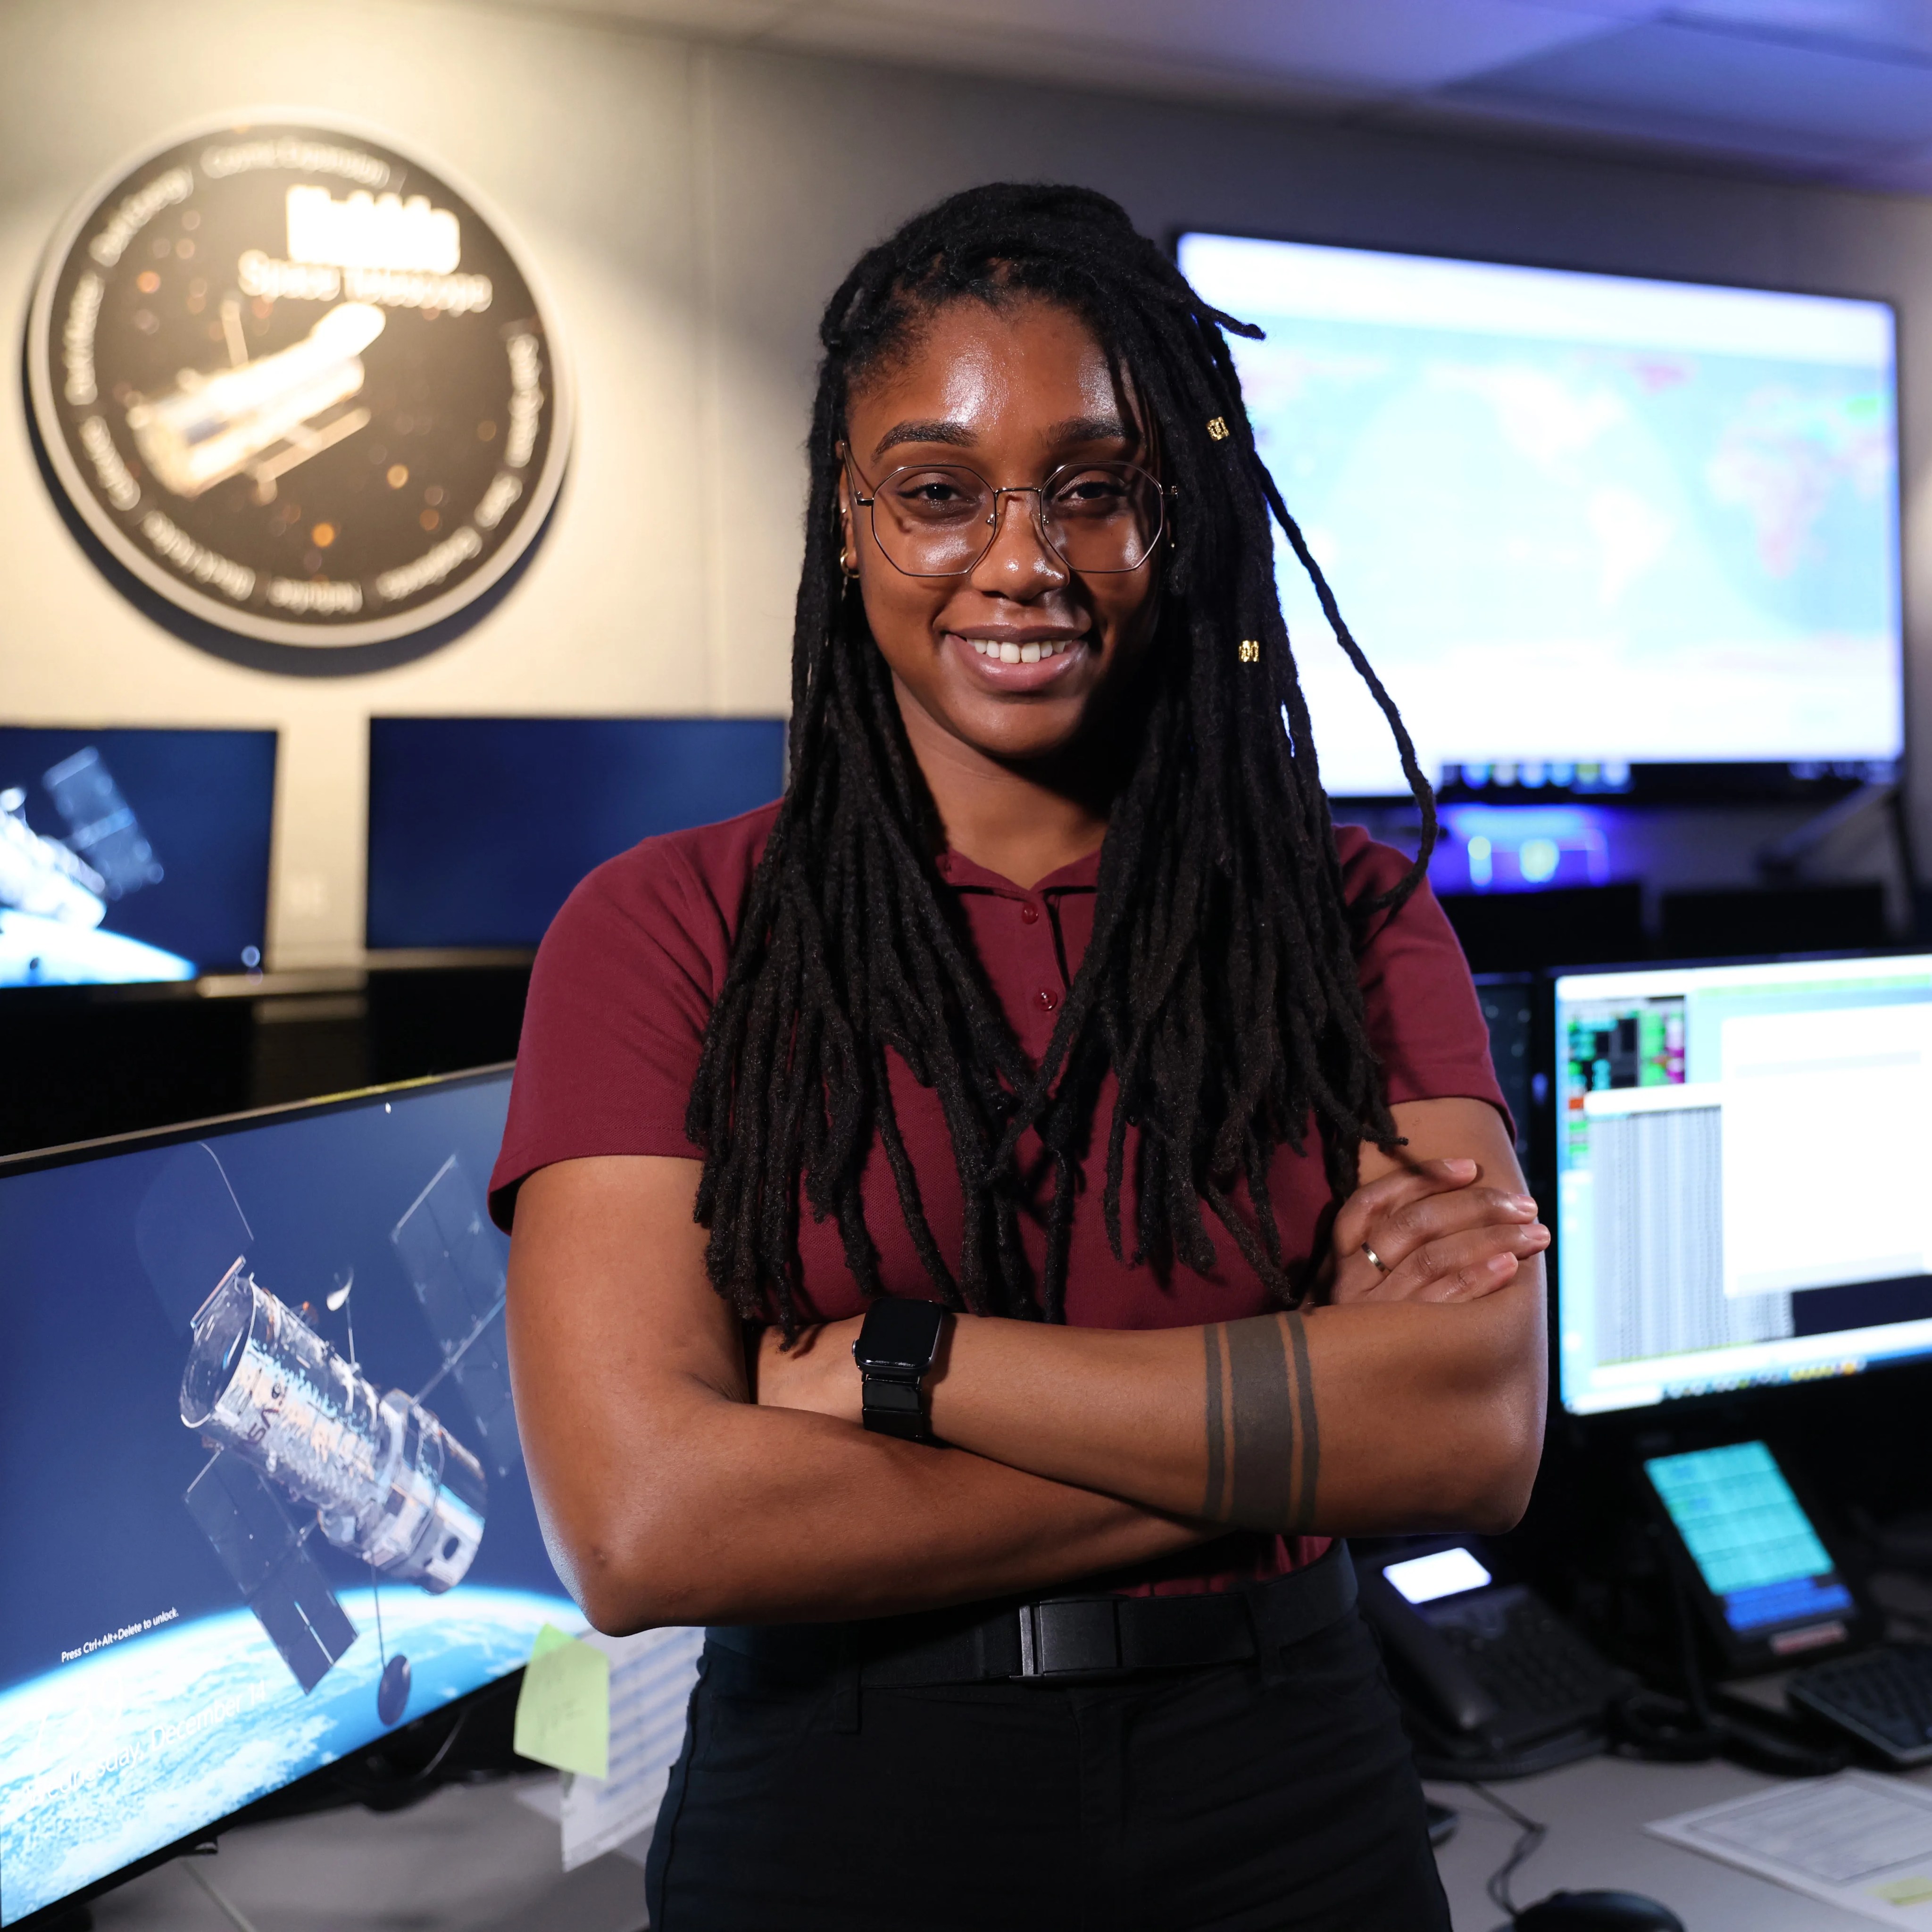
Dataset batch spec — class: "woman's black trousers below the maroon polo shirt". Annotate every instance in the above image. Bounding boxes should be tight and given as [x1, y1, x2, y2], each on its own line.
[647, 1609, 1449, 1932]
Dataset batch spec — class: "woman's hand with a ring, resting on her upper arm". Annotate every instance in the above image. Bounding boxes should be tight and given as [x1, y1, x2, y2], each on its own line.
[1327, 1159, 1549, 1302]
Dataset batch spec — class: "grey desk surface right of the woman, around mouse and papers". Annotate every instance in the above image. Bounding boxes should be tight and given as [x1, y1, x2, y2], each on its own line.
[1428, 1758, 1932, 1932]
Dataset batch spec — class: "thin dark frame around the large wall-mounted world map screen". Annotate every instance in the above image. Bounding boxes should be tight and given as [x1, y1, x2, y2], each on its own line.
[1167, 222, 1913, 806]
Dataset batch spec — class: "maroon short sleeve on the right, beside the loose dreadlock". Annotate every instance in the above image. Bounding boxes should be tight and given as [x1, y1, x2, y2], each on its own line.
[1335, 825, 1515, 1132]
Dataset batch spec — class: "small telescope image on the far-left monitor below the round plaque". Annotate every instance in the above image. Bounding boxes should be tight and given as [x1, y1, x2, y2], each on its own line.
[0, 724, 276, 985]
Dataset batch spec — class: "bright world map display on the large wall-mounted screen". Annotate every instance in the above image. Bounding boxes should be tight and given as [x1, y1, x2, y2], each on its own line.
[1181, 234, 1903, 796]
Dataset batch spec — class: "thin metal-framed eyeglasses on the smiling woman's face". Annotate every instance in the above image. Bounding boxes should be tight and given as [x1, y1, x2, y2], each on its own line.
[852, 464, 1173, 578]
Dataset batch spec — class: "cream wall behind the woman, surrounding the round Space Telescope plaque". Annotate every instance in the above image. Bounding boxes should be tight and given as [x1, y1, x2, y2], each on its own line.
[0, 0, 1932, 966]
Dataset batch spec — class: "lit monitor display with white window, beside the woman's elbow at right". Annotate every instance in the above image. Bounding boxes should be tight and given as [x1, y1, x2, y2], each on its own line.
[1553, 954, 1932, 1416]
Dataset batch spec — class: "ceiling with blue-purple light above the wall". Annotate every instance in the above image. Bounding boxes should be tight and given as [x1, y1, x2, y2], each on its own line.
[491, 0, 1932, 192]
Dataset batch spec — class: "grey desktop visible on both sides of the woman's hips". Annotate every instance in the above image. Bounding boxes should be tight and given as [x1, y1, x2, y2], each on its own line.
[75, 1758, 1932, 1932]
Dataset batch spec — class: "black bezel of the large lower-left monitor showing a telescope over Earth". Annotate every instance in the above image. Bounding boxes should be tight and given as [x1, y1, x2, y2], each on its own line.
[0, 1061, 545, 1932]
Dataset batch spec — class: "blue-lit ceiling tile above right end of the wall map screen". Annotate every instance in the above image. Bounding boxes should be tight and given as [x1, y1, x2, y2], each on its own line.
[1443, 25, 1932, 160]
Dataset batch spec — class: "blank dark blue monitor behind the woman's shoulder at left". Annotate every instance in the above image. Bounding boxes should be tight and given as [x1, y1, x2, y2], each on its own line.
[367, 719, 784, 950]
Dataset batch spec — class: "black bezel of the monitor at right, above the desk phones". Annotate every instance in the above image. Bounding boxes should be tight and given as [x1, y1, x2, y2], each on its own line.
[1534, 941, 1932, 1447]
